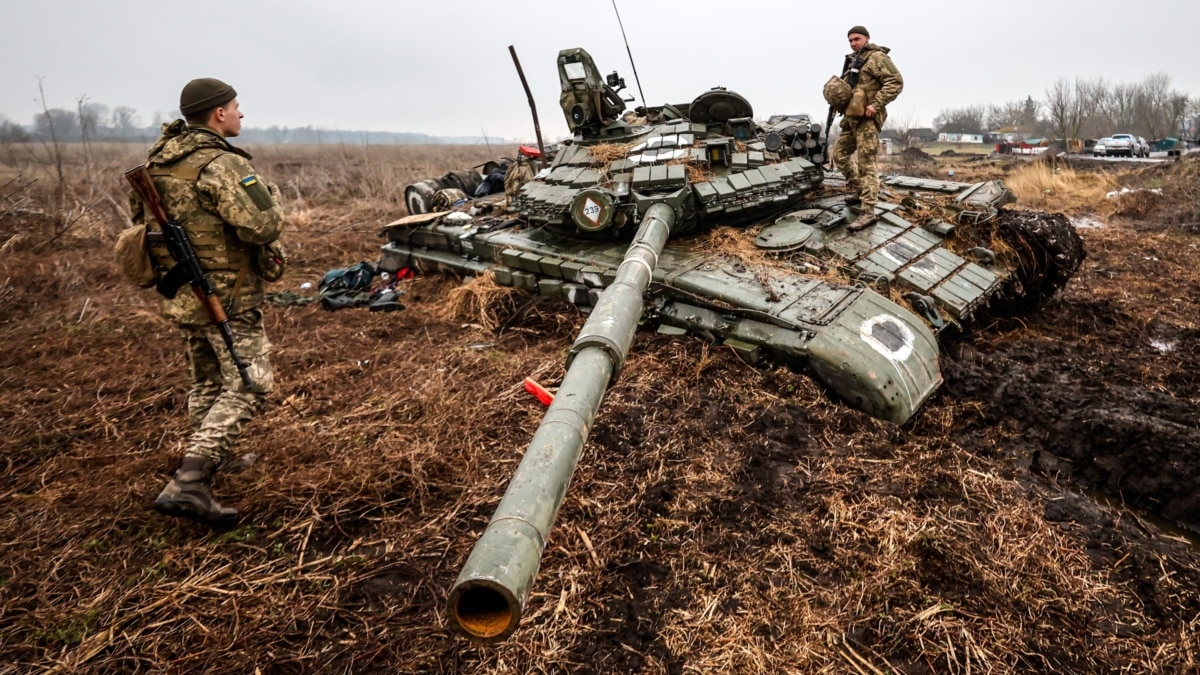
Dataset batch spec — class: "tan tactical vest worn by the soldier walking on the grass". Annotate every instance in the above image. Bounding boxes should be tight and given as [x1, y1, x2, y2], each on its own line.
[148, 148, 250, 271]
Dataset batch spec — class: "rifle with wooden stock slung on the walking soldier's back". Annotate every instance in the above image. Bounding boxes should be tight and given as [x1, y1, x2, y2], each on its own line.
[125, 165, 254, 387]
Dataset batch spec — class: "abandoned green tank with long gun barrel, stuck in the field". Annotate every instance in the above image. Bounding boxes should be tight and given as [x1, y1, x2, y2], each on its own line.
[380, 49, 1084, 643]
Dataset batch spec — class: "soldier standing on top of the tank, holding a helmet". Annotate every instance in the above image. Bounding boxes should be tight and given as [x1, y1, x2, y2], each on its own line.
[833, 25, 904, 232]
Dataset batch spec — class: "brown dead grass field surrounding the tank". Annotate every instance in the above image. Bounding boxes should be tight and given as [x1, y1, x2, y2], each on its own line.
[0, 139, 1200, 674]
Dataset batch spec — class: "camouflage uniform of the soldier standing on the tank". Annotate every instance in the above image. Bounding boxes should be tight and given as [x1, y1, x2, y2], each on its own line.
[833, 43, 904, 207]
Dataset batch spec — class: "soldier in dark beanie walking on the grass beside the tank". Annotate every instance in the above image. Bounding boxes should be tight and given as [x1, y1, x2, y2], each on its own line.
[132, 78, 284, 526]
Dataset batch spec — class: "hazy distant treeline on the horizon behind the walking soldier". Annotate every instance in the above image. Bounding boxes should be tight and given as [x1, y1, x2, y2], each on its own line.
[0, 102, 501, 145]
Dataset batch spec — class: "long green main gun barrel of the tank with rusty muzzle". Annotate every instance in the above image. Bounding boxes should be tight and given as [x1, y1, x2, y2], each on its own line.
[446, 202, 677, 643]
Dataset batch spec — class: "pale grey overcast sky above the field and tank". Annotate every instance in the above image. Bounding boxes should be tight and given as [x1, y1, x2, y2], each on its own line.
[0, 0, 1200, 138]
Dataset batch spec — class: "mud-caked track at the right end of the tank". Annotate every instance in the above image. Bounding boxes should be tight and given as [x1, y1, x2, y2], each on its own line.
[990, 209, 1087, 316]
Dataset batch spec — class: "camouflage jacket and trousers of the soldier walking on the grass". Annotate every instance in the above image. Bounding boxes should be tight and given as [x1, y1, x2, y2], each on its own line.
[132, 120, 284, 465]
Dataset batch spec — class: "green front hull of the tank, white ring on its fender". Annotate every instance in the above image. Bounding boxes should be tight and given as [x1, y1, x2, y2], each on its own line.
[380, 213, 942, 424]
